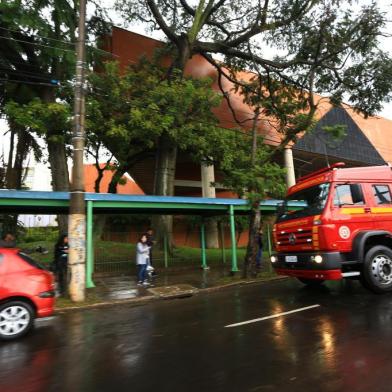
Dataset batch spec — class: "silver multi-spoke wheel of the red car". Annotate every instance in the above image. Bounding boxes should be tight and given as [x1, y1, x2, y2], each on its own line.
[0, 301, 34, 340]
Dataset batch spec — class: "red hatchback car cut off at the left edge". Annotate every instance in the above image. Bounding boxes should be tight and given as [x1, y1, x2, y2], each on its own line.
[0, 248, 55, 340]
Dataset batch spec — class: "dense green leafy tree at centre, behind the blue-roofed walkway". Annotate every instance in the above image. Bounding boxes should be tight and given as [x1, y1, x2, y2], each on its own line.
[87, 60, 230, 245]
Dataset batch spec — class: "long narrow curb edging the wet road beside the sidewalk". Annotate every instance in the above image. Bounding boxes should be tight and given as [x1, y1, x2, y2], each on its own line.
[54, 276, 288, 314]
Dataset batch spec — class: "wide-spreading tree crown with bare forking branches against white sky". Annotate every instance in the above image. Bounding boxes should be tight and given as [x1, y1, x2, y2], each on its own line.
[117, 0, 392, 114]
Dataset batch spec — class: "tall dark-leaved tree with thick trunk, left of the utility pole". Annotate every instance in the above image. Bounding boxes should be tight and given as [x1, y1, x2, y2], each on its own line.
[0, 0, 107, 231]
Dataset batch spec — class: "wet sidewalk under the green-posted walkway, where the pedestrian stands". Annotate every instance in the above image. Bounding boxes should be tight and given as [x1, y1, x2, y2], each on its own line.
[56, 266, 277, 310]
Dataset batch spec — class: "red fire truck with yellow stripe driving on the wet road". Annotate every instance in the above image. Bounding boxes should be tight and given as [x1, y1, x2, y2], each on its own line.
[271, 163, 392, 293]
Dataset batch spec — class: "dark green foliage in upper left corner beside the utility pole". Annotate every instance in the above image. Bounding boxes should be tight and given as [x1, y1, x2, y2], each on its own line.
[0, 0, 105, 173]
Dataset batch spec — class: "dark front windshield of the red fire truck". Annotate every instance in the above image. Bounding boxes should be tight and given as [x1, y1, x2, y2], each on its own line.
[277, 183, 330, 222]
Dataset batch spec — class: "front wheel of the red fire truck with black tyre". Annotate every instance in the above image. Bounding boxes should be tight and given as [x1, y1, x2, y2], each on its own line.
[363, 245, 392, 294]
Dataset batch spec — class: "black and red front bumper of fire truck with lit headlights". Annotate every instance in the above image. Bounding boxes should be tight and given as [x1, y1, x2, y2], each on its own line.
[271, 252, 345, 280]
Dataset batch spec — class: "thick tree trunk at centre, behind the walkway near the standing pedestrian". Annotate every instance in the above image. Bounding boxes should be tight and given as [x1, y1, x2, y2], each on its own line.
[153, 135, 177, 252]
